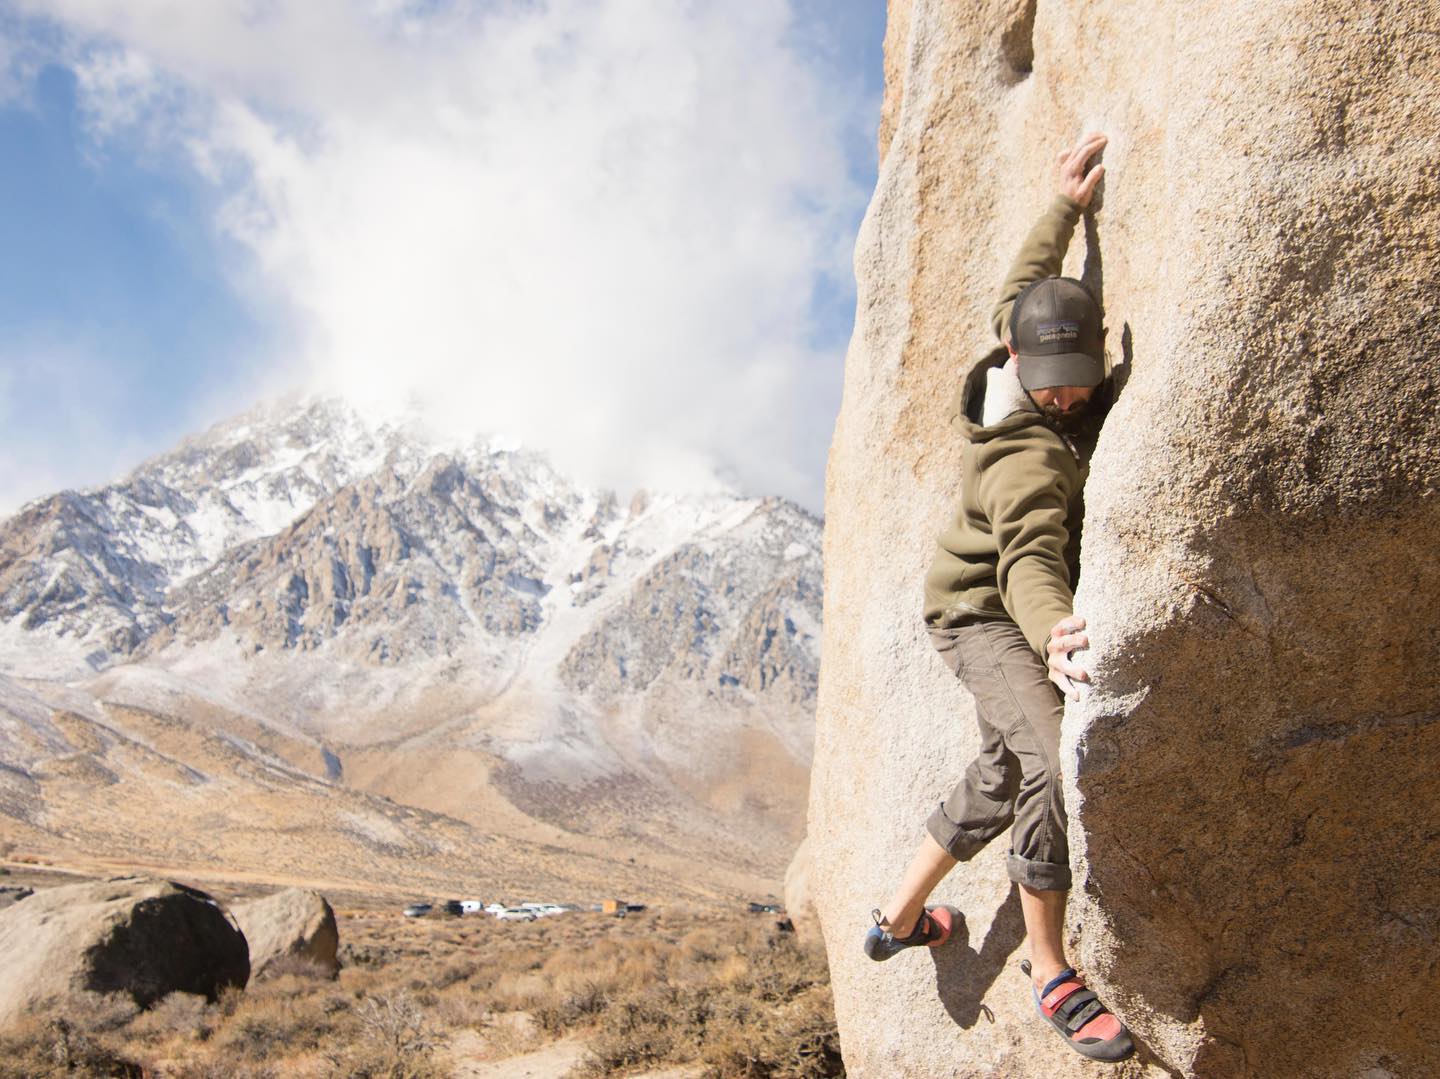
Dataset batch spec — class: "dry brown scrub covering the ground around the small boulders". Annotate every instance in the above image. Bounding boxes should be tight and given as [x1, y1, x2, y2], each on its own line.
[0, 912, 842, 1079]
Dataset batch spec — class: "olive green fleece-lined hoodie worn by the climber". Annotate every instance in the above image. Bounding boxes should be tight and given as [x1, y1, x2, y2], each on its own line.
[924, 196, 1109, 654]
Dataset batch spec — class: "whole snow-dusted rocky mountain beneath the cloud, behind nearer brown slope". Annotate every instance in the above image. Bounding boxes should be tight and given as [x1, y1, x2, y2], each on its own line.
[0, 399, 821, 893]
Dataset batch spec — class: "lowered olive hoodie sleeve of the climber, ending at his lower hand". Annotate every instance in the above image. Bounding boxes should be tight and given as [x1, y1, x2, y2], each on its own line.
[978, 428, 1079, 655]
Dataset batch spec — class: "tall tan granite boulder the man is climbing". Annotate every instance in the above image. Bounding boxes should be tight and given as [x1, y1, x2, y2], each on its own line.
[809, 0, 1440, 1076]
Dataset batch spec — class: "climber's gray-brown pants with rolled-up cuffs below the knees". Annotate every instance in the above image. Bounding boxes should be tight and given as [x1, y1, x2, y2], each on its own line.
[926, 619, 1070, 892]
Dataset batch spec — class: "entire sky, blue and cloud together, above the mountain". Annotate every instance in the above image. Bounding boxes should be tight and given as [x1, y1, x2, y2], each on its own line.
[0, 0, 884, 514]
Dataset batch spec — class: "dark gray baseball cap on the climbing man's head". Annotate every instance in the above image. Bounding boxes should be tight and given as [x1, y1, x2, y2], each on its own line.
[1009, 277, 1104, 389]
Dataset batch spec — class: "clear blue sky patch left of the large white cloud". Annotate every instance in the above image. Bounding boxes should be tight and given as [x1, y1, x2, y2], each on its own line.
[0, 65, 274, 513]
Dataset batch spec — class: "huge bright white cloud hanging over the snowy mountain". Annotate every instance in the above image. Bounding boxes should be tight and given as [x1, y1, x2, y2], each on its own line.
[16, 0, 864, 507]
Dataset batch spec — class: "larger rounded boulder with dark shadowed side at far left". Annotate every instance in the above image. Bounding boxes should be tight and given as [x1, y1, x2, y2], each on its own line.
[0, 877, 249, 1027]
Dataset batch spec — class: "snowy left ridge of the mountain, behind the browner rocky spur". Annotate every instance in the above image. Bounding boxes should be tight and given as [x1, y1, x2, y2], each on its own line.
[0, 400, 417, 671]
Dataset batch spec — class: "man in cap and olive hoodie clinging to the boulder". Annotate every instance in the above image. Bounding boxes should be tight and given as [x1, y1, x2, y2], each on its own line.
[865, 133, 1135, 1060]
